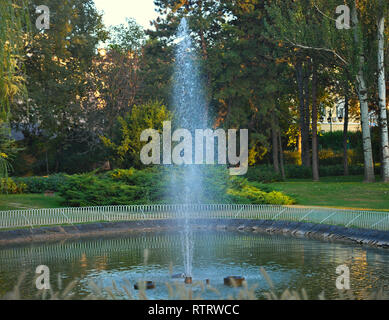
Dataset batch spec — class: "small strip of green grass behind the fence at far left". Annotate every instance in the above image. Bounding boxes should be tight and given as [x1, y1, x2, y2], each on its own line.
[0, 194, 63, 210]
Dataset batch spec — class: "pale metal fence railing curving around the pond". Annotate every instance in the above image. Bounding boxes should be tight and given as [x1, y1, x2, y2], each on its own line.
[0, 204, 389, 231]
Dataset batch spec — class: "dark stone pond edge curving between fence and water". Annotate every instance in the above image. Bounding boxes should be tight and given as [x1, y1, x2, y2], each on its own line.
[0, 219, 389, 248]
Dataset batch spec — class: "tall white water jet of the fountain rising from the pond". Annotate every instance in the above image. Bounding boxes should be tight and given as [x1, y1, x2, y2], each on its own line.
[171, 18, 206, 283]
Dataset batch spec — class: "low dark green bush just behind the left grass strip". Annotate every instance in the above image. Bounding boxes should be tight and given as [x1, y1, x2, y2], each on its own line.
[14, 174, 67, 193]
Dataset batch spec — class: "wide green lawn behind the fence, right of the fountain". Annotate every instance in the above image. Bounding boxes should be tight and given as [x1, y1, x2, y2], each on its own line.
[271, 176, 389, 211]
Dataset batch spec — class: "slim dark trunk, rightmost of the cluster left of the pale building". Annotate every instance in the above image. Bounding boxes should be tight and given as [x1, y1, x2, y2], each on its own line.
[312, 62, 320, 181]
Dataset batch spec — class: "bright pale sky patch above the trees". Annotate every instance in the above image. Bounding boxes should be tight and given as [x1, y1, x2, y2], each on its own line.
[95, 0, 158, 29]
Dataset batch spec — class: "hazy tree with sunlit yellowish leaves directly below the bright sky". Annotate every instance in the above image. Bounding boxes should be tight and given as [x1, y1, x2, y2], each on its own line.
[88, 19, 145, 136]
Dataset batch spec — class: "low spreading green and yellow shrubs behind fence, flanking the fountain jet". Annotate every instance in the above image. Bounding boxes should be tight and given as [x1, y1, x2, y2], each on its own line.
[60, 167, 293, 207]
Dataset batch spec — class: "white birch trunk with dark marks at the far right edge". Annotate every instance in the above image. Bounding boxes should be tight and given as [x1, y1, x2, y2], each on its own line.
[378, 16, 389, 183]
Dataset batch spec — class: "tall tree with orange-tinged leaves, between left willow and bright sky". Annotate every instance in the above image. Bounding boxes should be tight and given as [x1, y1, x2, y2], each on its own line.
[12, 0, 106, 171]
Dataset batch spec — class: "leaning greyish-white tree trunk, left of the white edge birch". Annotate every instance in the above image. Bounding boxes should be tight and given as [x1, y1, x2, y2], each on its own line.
[352, 1, 375, 182]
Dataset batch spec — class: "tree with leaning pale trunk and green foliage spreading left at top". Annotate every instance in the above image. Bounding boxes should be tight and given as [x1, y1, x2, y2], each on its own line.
[269, 1, 382, 182]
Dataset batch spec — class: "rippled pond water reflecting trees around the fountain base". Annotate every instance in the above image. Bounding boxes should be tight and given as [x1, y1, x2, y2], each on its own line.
[0, 231, 389, 299]
